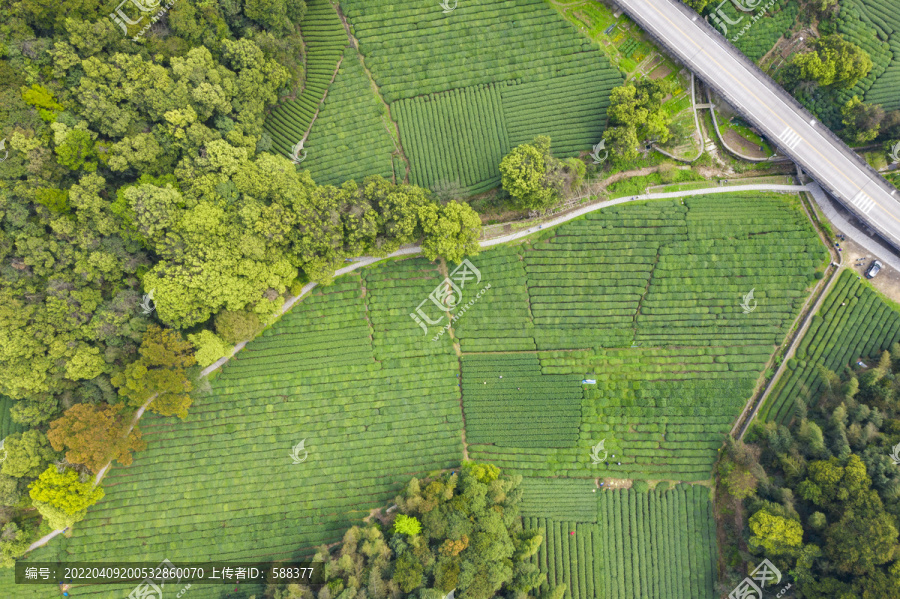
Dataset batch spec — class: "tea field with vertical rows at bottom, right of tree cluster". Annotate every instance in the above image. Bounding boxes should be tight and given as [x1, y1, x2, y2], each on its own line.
[524, 483, 717, 599]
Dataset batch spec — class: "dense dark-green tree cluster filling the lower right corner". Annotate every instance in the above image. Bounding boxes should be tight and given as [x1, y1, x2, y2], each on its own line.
[718, 344, 900, 599]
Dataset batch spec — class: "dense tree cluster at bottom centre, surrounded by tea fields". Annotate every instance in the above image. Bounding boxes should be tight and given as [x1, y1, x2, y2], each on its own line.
[267, 462, 565, 599]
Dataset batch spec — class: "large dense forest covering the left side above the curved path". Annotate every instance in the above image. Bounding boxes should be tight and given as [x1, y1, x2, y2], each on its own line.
[0, 0, 480, 557]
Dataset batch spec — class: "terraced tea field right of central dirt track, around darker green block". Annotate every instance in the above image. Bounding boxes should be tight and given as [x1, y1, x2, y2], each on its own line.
[455, 196, 825, 480]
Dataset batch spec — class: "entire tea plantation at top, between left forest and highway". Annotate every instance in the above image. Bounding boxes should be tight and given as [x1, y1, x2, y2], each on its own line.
[266, 0, 622, 195]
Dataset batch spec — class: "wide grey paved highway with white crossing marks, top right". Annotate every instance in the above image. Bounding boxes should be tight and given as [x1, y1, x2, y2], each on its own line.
[616, 0, 900, 249]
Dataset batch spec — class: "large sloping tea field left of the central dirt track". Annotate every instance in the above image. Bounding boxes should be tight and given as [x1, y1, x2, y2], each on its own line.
[8, 268, 462, 599]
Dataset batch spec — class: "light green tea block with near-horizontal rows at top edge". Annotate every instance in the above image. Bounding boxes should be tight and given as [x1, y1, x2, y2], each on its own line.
[341, 0, 603, 102]
